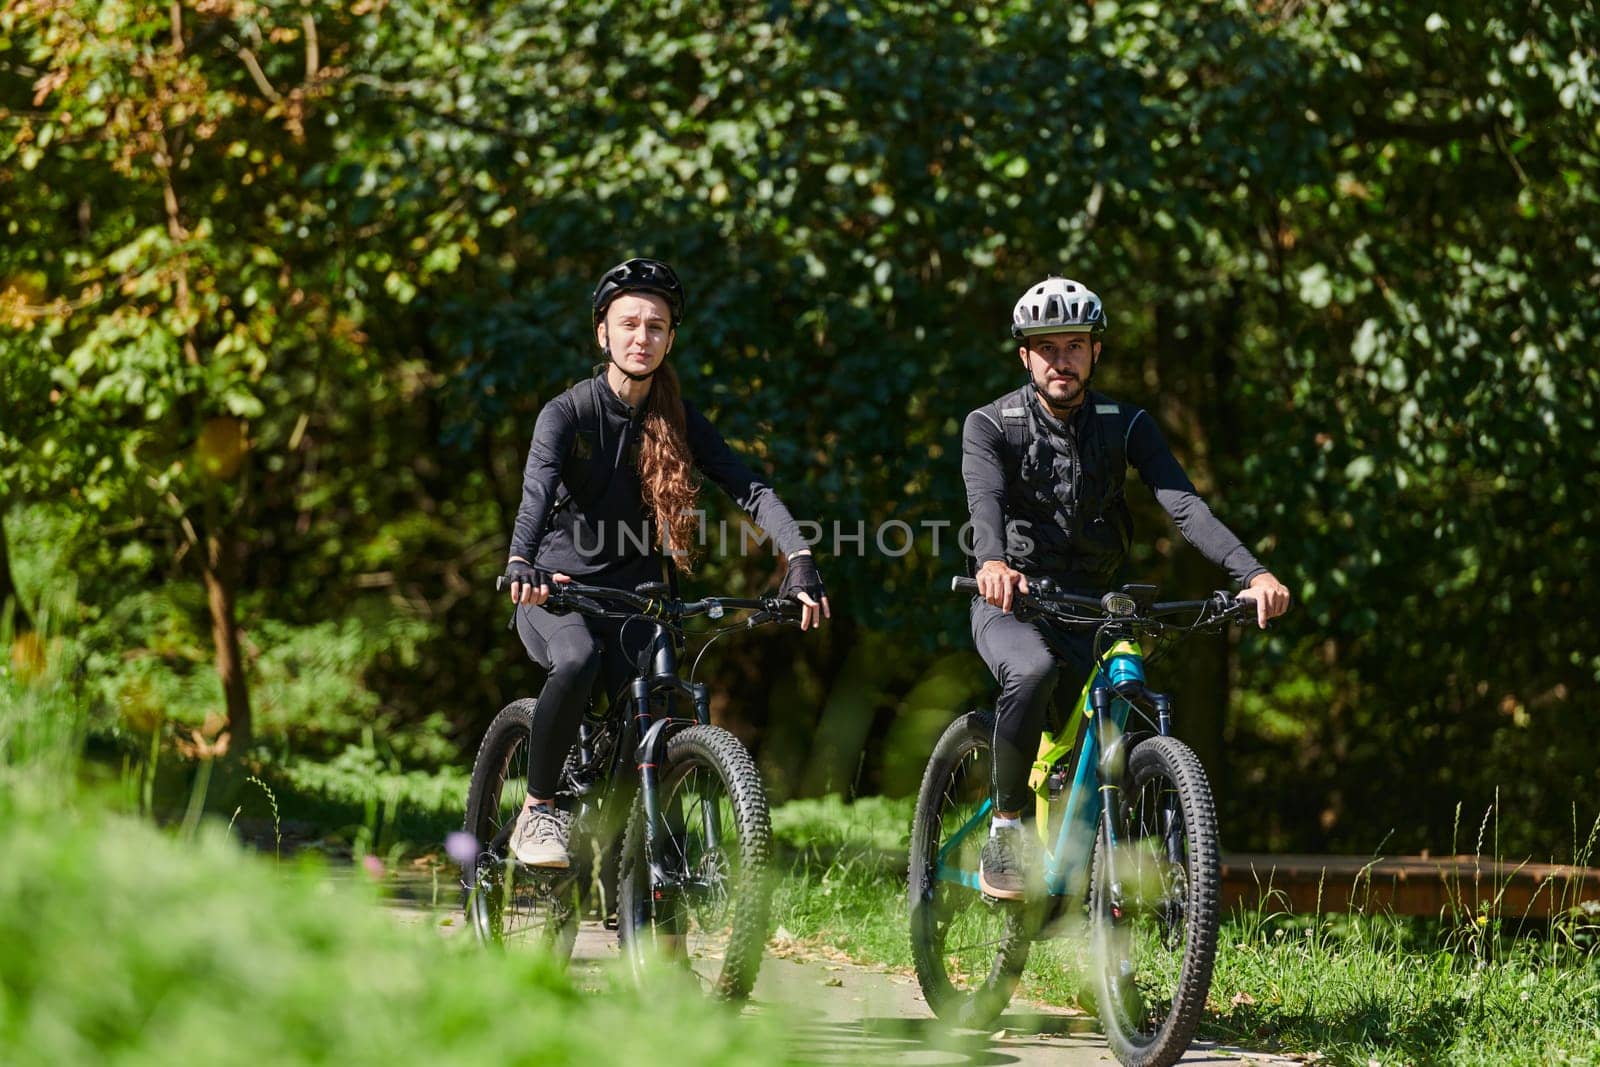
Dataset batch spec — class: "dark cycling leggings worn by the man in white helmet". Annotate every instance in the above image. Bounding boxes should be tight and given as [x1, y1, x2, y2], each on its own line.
[971, 597, 1094, 811]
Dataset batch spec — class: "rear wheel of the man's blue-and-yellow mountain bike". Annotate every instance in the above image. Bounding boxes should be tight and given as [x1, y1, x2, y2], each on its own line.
[907, 712, 1030, 1027]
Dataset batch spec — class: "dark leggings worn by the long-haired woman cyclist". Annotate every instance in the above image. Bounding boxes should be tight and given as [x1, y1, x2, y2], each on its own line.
[517, 605, 654, 800]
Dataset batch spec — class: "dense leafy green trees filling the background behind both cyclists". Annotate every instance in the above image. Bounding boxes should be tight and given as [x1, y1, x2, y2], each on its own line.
[0, 0, 1600, 854]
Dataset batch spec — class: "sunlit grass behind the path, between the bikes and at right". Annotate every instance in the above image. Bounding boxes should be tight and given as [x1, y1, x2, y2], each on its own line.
[773, 798, 1600, 1067]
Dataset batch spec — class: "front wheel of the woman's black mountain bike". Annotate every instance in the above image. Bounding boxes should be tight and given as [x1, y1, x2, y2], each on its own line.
[618, 726, 773, 1000]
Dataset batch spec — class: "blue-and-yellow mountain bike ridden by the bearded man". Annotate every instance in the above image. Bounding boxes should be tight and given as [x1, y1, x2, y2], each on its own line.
[909, 577, 1256, 1067]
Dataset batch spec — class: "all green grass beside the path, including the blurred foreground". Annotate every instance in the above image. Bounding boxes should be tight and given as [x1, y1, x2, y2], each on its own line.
[12, 579, 1600, 1065]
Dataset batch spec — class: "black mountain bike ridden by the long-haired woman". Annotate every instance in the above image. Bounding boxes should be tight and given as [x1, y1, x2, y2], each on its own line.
[461, 576, 802, 1000]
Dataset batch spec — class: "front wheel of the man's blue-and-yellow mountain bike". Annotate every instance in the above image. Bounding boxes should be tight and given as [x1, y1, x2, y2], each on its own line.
[1090, 737, 1222, 1067]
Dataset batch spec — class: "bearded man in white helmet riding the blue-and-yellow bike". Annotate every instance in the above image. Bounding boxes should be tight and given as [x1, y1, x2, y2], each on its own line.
[962, 275, 1290, 901]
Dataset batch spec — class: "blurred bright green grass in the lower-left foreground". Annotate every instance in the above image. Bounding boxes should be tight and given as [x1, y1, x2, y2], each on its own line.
[0, 617, 800, 1065]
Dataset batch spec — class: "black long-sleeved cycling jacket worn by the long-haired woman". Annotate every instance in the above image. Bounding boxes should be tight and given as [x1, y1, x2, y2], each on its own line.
[510, 370, 806, 585]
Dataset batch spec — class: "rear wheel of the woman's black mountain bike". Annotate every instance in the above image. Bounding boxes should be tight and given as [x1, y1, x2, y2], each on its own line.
[461, 699, 578, 963]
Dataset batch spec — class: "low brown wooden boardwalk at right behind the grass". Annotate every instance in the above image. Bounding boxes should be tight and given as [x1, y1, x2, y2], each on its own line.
[1222, 853, 1600, 920]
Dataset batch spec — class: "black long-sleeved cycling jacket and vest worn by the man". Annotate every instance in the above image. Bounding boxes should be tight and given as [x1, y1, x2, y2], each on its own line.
[962, 384, 1267, 592]
